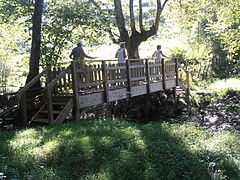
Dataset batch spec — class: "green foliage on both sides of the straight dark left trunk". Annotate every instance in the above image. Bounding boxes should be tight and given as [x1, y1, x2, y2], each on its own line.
[0, 0, 113, 89]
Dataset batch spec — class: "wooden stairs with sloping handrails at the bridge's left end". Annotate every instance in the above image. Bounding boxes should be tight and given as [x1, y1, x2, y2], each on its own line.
[0, 65, 74, 126]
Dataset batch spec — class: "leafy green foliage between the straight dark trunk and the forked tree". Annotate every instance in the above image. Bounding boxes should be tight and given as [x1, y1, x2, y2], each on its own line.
[42, 1, 110, 65]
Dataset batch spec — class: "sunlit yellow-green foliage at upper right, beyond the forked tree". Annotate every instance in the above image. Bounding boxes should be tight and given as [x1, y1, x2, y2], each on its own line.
[168, 0, 240, 79]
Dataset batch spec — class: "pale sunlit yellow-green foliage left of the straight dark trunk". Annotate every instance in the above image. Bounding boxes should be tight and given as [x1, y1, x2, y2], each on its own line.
[0, 23, 29, 92]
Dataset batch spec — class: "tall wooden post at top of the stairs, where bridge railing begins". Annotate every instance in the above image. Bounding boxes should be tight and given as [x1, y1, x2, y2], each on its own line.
[71, 61, 80, 120]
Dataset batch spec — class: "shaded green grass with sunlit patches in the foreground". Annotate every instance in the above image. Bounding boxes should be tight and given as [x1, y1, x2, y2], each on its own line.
[0, 119, 240, 180]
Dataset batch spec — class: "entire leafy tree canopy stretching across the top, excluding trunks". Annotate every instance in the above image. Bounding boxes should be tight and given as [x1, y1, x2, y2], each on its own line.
[0, 0, 240, 90]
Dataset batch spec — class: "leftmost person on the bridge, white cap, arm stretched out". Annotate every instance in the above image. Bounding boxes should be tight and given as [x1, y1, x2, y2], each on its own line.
[69, 40, 96, 66]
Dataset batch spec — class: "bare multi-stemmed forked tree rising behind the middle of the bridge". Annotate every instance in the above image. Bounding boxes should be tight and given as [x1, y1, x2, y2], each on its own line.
[112, 0, 168, 59]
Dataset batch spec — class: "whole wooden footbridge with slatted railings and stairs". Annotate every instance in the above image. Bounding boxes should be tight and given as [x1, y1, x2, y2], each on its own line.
[0, 59, 189, 125]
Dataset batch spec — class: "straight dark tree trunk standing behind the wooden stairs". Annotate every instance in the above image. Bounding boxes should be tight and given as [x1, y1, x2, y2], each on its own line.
[26, 0, 43, 88]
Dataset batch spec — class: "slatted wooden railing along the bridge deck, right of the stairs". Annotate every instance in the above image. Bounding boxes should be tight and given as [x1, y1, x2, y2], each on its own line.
[70, 59, 177, 93]
